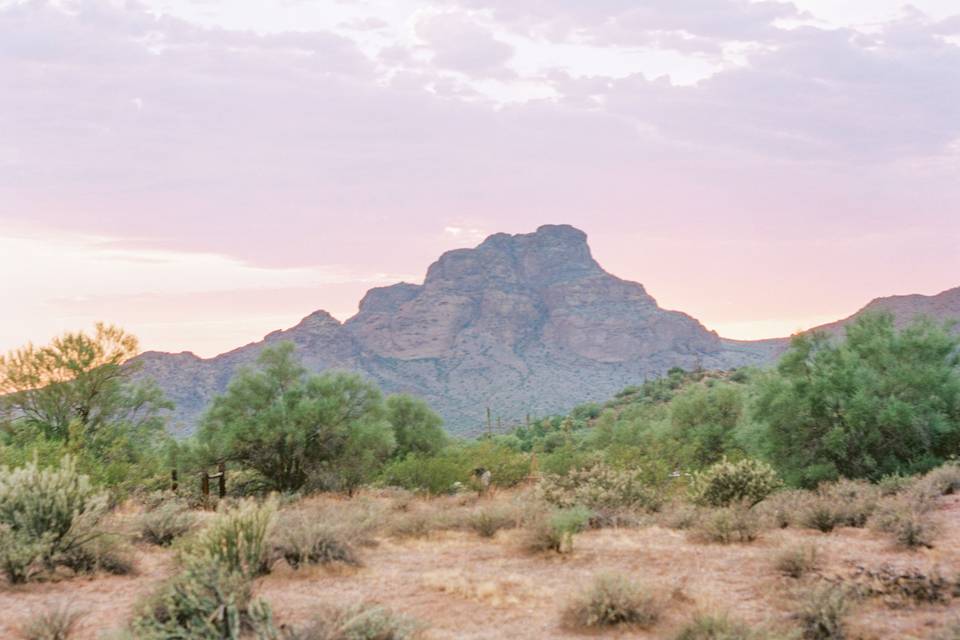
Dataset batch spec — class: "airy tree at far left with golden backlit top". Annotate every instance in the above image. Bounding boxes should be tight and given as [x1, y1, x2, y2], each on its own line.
[0, 324, 172, 490]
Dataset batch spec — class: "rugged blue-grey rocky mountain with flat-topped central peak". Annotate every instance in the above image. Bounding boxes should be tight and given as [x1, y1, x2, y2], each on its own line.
[137, 225, 960, 434]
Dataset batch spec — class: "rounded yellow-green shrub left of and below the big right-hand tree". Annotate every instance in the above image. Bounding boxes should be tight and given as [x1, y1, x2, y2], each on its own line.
[690, 458, 781, 507]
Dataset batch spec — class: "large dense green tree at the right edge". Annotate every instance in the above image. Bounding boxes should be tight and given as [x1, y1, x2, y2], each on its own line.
[755, 313, 960, 486]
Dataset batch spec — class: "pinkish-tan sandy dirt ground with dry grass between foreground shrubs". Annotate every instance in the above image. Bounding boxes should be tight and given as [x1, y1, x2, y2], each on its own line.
[0, 496, 960, 640]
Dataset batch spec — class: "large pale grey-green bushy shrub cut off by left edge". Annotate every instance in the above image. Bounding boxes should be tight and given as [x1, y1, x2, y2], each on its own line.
[0, 456, 108, 582]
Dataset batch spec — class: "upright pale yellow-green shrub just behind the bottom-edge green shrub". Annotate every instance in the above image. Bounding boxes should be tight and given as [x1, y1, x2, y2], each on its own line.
[189, 499, 276, 578]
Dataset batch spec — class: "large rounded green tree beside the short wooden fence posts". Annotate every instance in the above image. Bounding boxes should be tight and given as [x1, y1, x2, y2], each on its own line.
[198, 343, 395, 491]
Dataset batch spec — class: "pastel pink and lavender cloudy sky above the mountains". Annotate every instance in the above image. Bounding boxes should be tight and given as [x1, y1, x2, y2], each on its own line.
[0, 0, 960, 355]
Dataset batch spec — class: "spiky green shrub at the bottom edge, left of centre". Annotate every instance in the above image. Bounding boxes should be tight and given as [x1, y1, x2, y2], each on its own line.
[131, 558, 275, 640]
